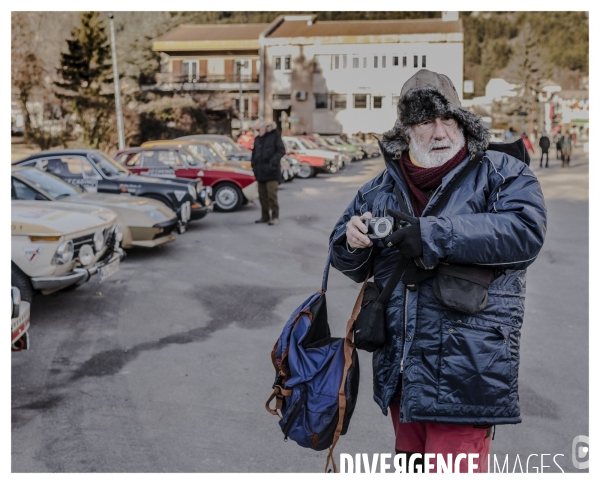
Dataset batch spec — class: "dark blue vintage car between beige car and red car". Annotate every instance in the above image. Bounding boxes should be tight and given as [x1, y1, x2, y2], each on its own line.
[14, 149, 210, 232]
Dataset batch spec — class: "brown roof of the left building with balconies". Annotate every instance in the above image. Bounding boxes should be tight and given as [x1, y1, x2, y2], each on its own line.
[153, 24, 269, 51]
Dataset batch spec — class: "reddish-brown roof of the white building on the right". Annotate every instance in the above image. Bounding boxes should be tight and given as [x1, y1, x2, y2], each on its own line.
[268, 19, 463, 38]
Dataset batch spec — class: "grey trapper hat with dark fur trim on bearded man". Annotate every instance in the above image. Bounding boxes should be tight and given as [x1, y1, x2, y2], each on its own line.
[381, 69, 490, 158]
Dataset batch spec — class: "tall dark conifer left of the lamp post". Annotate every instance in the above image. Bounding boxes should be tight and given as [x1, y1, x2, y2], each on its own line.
[54, 12, 116, 148]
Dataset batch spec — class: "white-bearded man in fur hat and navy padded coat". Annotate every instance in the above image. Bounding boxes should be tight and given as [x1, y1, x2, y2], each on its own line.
[330, 69, 546, 472]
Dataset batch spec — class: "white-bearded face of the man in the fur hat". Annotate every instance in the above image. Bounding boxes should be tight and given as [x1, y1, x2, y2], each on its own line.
[408, 117, 465, 168]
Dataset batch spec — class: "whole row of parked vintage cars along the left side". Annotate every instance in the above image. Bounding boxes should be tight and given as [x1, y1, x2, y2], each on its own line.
[11, 135, 380, 350]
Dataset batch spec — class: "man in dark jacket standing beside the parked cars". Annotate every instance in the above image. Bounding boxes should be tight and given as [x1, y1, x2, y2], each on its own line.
[251, 119, 285, 225]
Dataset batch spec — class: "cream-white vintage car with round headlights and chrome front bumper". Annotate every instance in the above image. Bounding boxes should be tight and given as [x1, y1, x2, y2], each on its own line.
[11, 200, 125, 302]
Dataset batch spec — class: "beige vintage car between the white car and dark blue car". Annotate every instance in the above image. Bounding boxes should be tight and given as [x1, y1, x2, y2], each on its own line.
[11, 166, 177, 249]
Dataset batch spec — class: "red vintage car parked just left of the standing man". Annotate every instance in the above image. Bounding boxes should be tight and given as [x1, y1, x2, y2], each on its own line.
[113, 145, 258, 212]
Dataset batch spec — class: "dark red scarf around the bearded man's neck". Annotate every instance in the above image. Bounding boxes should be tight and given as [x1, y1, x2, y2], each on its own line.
[400, 143, 467, 217]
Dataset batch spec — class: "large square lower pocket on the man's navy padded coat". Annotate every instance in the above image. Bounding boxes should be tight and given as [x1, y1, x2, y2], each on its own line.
[438, 318, 513, 407]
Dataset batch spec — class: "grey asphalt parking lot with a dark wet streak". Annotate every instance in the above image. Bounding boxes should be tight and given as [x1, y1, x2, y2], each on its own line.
[11, 149, 589, 472]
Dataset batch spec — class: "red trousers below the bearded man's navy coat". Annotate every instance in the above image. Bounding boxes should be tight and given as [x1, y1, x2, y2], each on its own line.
[390, 404, 492, 473]
